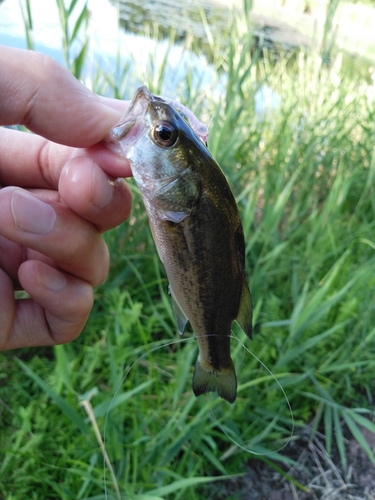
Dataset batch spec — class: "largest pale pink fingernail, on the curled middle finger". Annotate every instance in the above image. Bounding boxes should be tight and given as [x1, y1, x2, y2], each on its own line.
[11, 189, 56, 234]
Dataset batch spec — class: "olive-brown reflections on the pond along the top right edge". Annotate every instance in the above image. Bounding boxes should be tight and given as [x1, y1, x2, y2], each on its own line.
[110, 0, 373, 81]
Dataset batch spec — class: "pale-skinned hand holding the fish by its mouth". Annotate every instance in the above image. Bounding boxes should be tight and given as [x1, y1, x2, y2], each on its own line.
[0, 46, 131, 350]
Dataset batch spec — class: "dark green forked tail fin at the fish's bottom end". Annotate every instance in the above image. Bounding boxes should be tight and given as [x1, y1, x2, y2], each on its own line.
[193, 359, 237, 403]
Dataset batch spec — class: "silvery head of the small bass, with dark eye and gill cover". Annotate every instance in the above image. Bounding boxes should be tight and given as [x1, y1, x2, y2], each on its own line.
[109, 86, 208, 218]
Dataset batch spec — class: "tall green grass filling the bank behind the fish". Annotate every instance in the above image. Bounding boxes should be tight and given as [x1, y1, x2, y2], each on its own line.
[0, 1, 375, 500]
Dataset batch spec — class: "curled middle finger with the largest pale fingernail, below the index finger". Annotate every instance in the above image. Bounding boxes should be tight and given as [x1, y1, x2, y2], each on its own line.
[0, 187, 109, 286]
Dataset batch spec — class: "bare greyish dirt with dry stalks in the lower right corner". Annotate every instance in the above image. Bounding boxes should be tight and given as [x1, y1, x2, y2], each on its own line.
[211, 429, 375, 500]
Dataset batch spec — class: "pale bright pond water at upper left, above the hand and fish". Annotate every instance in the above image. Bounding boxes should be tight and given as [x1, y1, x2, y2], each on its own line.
[0, 0, 234, 97]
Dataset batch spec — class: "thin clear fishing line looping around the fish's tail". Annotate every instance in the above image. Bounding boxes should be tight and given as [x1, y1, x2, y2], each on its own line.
[103, 333, 295, 499]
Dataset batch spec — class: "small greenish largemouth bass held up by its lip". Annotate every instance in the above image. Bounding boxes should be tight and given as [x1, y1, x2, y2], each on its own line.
[107, 85, 252, 403]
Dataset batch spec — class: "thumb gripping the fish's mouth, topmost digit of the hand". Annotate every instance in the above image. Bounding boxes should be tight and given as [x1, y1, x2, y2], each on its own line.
[0, 46, 126, 148]
